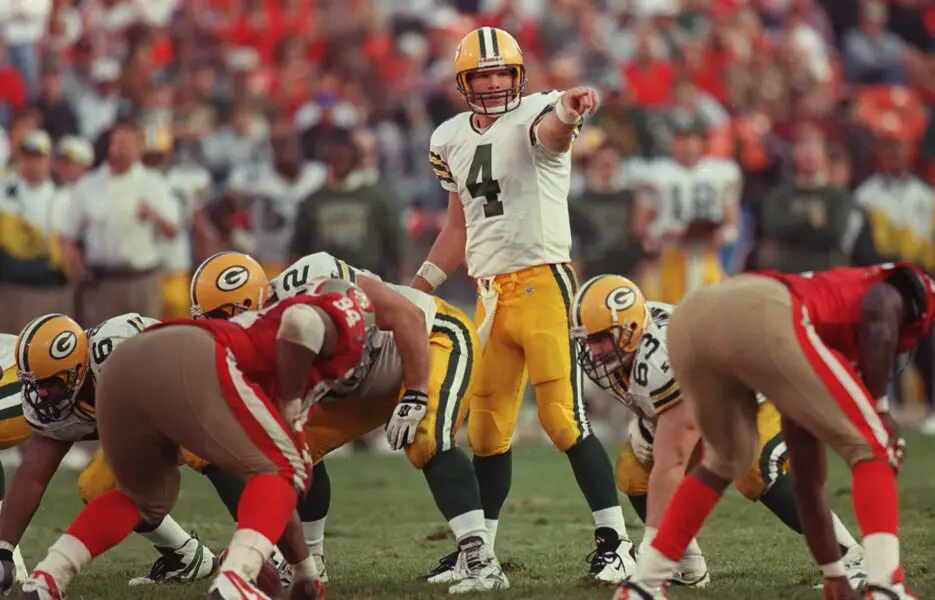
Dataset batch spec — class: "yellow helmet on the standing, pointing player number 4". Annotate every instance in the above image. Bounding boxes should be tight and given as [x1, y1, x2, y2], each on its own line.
[455, 27, 526, 115]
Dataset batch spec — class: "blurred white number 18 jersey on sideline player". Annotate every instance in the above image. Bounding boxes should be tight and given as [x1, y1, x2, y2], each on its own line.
[638, 158, 743, 236]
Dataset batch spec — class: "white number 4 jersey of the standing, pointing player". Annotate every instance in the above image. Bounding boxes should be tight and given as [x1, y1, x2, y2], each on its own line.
[429, 91, 571, 278]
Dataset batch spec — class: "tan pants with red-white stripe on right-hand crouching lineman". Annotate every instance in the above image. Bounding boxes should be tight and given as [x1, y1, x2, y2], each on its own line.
[668, 275, 886, 480]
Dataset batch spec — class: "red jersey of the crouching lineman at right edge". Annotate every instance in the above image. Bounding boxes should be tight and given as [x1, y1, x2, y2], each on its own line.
[758, 262, 935, 362]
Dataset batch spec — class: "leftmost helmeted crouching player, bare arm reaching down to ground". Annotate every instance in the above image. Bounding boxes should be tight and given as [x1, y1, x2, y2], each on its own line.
[0, 313, 217, 590]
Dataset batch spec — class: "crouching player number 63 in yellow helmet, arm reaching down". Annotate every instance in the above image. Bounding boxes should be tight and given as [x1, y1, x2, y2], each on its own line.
[571, 275, 866, 588]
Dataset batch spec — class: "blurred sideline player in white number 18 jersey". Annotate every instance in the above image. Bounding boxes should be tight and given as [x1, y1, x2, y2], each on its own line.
[636, 123, 743, 304]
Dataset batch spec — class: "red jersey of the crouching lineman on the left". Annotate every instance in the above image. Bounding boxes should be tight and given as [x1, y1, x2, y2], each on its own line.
[146, 293, 367, 399]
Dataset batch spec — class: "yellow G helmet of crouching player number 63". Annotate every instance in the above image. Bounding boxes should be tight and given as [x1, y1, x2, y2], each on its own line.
[569, 275, 650, 388]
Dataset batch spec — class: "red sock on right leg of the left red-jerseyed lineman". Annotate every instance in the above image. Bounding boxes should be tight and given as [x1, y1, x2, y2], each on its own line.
[237, 475, 298, 542]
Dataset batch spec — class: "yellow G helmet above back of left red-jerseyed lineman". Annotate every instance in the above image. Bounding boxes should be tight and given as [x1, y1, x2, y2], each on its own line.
[190, 252, 269, 319]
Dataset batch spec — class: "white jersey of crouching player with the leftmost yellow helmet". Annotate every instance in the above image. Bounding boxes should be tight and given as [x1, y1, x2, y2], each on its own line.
[23, 313, 159, 442]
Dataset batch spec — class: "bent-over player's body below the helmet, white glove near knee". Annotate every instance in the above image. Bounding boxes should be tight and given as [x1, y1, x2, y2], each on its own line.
[193, 252, 509, 593]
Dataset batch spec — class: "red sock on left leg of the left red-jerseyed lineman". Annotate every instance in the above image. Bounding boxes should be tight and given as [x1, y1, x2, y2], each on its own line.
[65, 490, 140, 557]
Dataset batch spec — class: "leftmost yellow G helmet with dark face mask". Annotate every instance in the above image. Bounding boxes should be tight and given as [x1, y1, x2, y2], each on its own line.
[15, 314, 89, 422]
